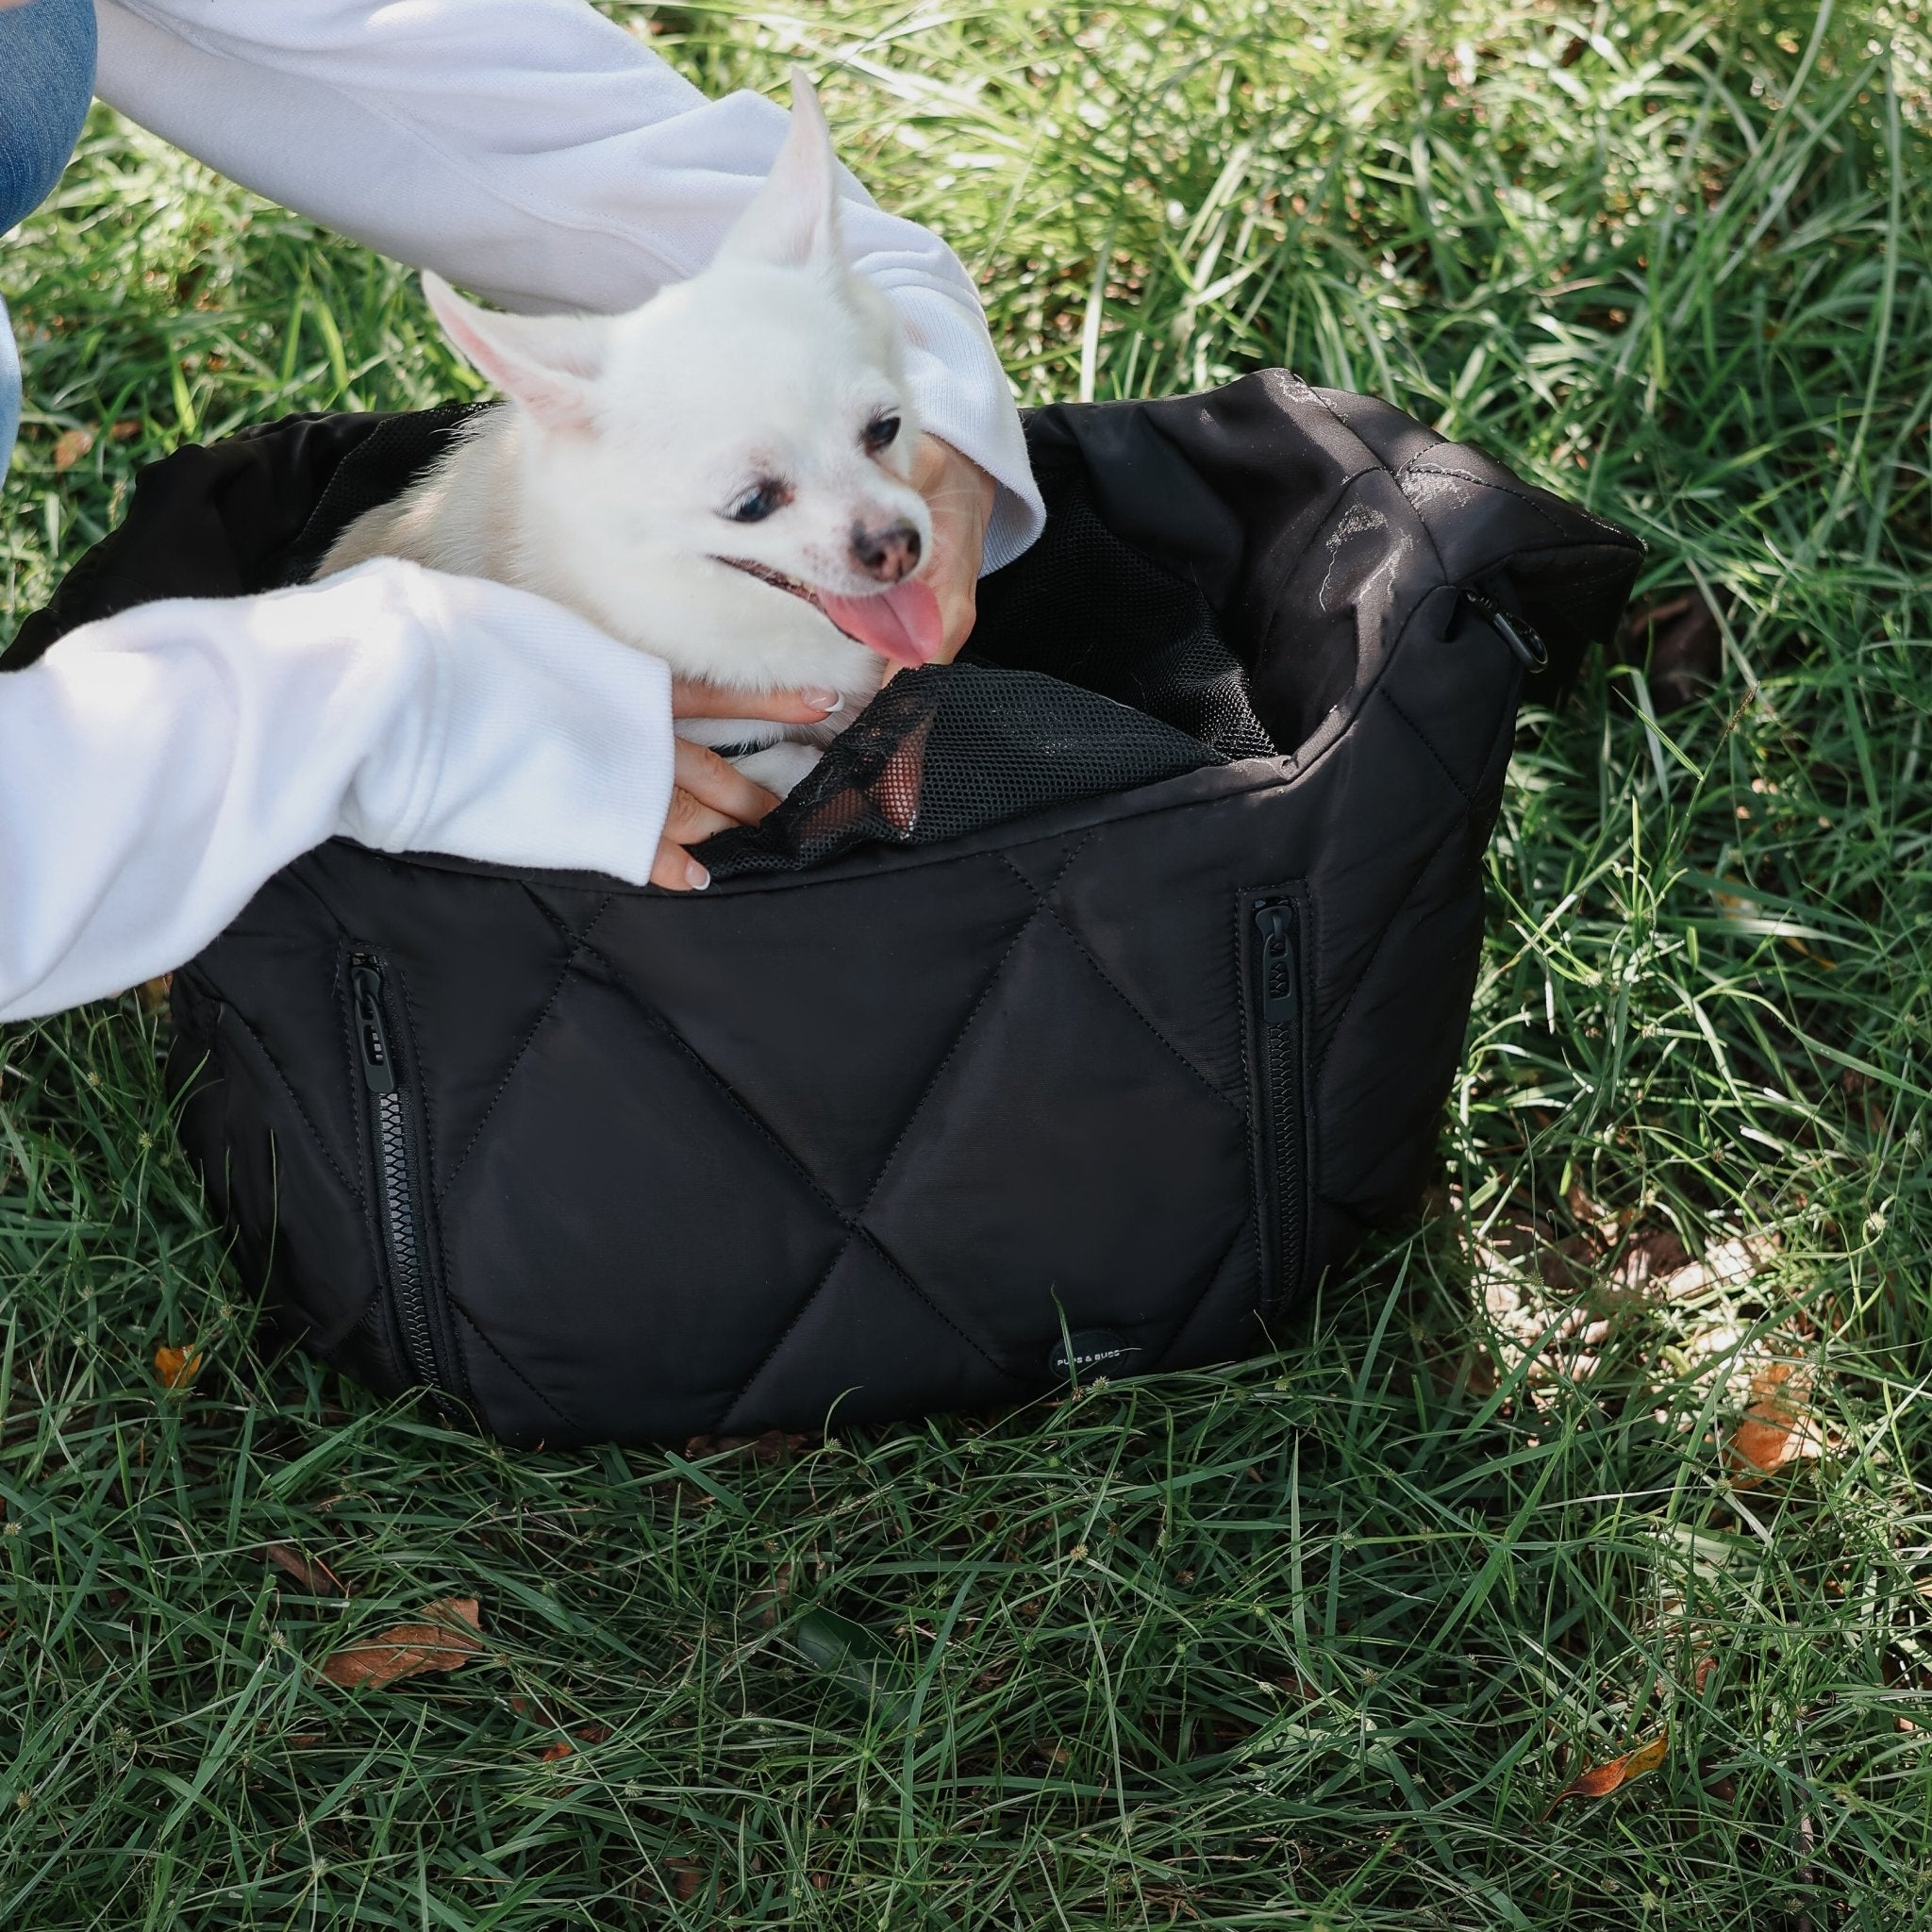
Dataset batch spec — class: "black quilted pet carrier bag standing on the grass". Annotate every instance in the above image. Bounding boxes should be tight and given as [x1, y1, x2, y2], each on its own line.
[9, 371, 1641, 1443]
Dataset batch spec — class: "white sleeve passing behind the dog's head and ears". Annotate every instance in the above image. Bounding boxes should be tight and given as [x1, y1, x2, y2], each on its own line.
[96, 0, 1045, 570]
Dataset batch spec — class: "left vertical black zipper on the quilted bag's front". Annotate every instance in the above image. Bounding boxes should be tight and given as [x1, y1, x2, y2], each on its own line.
[348, 953, 461, 1395]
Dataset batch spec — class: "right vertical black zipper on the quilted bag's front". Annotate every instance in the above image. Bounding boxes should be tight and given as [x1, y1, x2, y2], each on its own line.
[1242, 889, 1312, 1314]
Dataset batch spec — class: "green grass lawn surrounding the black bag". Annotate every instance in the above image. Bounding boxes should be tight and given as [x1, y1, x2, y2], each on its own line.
[0, 0, 1932, 1932]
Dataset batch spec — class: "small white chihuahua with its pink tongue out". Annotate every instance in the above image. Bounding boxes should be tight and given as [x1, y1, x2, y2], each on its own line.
[317, 70, 942, 796]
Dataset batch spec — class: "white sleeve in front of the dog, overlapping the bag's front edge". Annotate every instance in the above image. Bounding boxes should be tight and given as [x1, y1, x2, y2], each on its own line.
[0, 558, 673, 1020]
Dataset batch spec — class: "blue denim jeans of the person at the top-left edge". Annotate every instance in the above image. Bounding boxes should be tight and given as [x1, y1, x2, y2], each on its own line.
[0, 0, 94, 477]
